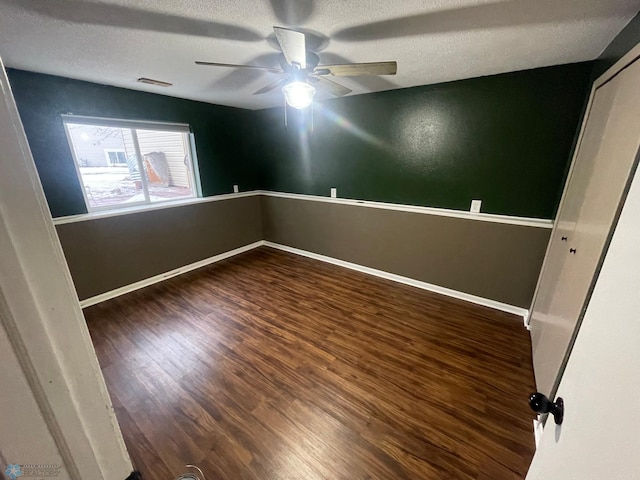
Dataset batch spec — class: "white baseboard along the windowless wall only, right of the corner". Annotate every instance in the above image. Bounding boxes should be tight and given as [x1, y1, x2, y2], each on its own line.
[264, 241, 529, 319]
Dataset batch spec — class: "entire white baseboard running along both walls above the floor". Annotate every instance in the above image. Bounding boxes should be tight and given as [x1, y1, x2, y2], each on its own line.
[80, 240, 529, 319]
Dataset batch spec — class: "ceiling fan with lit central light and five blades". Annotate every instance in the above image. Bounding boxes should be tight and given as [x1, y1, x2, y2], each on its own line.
[196, 27, 398, 109]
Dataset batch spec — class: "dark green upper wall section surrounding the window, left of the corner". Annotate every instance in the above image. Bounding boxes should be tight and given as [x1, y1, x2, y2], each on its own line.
[7, 69, 259, 217]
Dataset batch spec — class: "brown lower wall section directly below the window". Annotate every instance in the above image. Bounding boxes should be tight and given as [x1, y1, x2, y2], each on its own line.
[56, 196, 262, 300]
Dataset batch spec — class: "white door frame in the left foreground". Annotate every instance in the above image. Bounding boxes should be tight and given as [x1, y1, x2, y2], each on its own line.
[0, 55, 132, 480]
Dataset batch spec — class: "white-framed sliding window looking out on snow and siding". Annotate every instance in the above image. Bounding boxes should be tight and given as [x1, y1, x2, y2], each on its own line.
[63, 115, 198, 212]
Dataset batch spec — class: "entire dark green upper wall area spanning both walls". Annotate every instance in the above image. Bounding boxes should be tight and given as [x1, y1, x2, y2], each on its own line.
[8, 63, 592, 218]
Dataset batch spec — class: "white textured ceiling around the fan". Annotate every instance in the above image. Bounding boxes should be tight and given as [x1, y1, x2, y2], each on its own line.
[0, 0, 640, 109]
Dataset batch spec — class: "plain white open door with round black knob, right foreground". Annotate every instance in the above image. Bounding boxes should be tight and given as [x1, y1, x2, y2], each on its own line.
[527, 131, 640, 480]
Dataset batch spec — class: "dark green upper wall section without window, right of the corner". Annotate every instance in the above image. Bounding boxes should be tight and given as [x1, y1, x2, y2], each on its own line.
[252, 62, 593, 218]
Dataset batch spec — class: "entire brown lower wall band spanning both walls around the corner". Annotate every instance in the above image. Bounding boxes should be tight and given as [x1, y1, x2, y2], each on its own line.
[56, 195, 551, 308]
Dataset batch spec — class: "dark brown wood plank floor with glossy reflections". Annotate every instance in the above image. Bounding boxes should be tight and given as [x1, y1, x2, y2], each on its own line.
[85, 248, 534, 480]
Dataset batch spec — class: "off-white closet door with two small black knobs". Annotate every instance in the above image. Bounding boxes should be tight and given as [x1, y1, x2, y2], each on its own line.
[530, 54, 640, 395]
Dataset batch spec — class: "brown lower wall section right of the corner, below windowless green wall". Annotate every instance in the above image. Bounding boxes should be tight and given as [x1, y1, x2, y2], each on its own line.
[261, 196, 551, 308]
